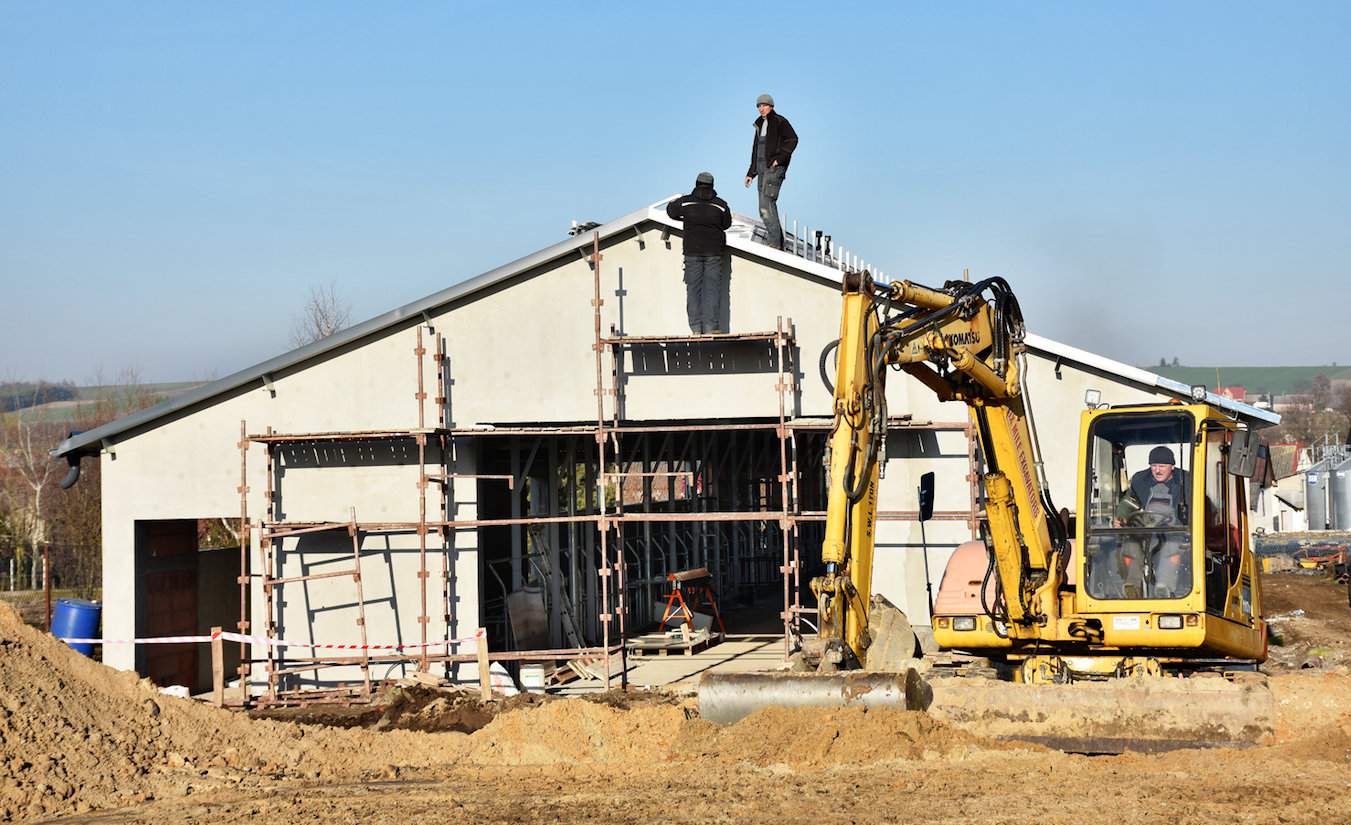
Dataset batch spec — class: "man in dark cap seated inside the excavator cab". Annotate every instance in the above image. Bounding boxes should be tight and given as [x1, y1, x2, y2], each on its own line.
[1115, 444, 1192, 598]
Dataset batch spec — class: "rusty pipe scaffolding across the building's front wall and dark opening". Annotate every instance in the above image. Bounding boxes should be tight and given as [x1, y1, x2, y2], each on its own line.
[229, 234, 978, 705]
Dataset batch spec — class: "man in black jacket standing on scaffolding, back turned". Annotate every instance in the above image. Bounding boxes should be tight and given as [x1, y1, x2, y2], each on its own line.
[666, 171, 732, 335]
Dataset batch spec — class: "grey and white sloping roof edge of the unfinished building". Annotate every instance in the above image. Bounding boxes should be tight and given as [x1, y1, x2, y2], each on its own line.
[51, 194, 1281, 458]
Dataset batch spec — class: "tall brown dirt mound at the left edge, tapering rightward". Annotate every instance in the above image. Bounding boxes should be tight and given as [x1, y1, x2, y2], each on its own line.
[0, 604, 463, 821]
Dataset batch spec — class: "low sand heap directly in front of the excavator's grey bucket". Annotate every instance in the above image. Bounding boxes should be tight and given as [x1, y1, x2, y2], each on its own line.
[676, 706, 1004, 768]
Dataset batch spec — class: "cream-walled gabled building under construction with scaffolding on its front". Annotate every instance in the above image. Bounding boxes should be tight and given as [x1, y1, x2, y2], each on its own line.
[57, 201, 1267, 702]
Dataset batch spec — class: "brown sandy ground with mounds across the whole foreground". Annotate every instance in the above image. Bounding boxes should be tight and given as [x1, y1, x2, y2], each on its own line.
[0, 575, 1351, 825]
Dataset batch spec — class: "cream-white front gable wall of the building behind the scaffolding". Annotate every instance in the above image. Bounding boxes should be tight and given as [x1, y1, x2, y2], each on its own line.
[101, 217, 1194, 683]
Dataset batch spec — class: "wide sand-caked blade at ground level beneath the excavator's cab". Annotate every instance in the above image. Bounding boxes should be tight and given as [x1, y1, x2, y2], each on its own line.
[928, 672, 1275, 753]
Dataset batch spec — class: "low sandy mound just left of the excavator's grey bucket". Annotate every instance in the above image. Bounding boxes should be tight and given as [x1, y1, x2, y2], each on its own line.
[470, 699, 686, 766]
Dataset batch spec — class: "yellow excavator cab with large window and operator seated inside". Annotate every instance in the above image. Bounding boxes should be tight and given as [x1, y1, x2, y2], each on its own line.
[1073, 404, 1266, 670]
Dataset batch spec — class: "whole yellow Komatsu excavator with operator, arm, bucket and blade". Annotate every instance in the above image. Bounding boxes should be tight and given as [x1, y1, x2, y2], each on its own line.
[698, 271, 1274, 752]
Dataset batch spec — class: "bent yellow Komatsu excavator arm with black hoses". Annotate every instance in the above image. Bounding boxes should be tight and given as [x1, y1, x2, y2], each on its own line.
[812, 273, 1069, 666]
